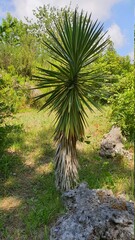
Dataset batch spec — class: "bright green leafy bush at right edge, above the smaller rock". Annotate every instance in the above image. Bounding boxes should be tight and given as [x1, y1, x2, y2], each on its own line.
[110, 66, 134, 140]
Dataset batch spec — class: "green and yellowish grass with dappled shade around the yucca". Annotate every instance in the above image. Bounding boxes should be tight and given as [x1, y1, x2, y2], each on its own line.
[0, 106, 133, 240]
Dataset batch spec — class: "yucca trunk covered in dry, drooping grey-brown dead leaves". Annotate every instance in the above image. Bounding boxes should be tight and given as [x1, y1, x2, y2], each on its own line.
[55, 137, 78, 191]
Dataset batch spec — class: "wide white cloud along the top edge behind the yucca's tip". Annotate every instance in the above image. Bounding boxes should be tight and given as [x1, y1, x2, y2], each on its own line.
[12, 0, 122, 20]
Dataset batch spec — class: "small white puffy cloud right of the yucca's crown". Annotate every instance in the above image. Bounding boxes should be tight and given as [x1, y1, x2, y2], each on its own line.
[108, 23, 126, 48]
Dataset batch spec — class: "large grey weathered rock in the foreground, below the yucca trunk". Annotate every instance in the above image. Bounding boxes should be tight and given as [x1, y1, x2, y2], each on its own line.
[50, 183, 134, 240]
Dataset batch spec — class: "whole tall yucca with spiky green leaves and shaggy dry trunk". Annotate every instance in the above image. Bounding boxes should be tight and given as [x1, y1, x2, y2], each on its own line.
[35, 10, 108, 190]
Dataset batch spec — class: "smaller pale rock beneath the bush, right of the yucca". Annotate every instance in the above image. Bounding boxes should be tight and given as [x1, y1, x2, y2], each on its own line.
[99, 126, 132, 159]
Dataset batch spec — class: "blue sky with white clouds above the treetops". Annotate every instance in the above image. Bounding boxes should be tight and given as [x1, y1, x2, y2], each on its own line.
[0, 0, 135, 60]
